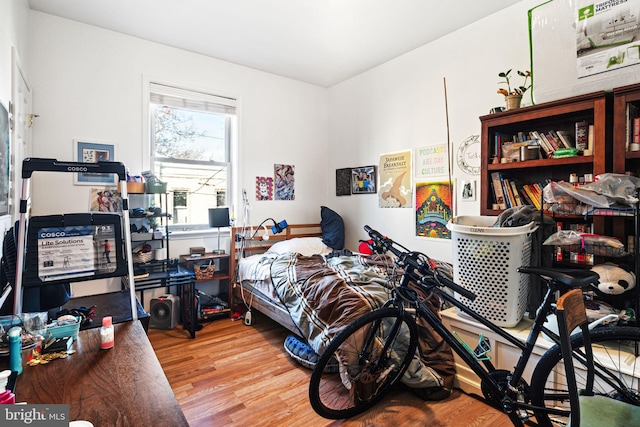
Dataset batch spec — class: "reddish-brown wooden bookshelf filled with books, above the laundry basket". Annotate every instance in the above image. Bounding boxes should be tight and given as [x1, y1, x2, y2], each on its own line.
[480, 89, 608, 219]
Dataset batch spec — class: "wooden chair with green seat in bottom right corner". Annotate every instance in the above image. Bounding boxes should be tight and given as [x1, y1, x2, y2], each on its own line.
[556, 289, 640, 427]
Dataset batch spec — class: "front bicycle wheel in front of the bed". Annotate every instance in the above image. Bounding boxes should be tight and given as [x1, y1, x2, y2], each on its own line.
[309, 308, 418, 419]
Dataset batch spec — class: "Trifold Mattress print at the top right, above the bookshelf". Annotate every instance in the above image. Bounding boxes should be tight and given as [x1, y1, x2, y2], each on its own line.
[575, 0, 640, 78]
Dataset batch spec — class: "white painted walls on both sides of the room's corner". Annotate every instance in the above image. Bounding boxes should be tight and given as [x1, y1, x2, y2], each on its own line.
[20, 0, 537, 300]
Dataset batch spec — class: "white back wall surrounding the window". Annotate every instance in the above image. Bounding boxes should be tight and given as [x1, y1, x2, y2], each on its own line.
[30, 11, 328, 227]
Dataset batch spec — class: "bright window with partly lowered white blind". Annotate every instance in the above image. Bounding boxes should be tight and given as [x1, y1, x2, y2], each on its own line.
[149, 83, 236, 230]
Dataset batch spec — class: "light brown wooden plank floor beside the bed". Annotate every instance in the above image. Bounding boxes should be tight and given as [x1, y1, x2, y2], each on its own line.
[149, 313, 511, 427]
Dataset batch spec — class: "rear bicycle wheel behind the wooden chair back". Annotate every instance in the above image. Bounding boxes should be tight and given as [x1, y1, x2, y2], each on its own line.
[531, 326, 640, 426]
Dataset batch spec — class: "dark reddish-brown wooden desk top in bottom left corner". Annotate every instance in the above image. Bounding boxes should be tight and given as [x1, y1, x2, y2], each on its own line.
[0, 321, 188, 427]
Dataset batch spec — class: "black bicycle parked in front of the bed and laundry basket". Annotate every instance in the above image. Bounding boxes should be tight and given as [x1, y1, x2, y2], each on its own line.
[309, 226, 640, 426]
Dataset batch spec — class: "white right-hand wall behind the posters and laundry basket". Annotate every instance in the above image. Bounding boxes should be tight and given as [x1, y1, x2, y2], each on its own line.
[329, 1, 539, 261]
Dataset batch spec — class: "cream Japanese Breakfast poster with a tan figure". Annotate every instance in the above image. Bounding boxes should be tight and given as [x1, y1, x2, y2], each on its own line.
[378, 150, 413, 208]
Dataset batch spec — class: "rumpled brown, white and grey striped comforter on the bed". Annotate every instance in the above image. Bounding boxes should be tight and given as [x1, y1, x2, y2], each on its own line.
[271, 253, 455, 388]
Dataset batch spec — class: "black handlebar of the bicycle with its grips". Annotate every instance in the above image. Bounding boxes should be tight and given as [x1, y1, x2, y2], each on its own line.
[364, 225, 476, 301]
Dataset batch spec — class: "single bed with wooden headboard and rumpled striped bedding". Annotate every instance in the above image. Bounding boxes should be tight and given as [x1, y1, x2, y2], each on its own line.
[230, 217, 455, 394]
